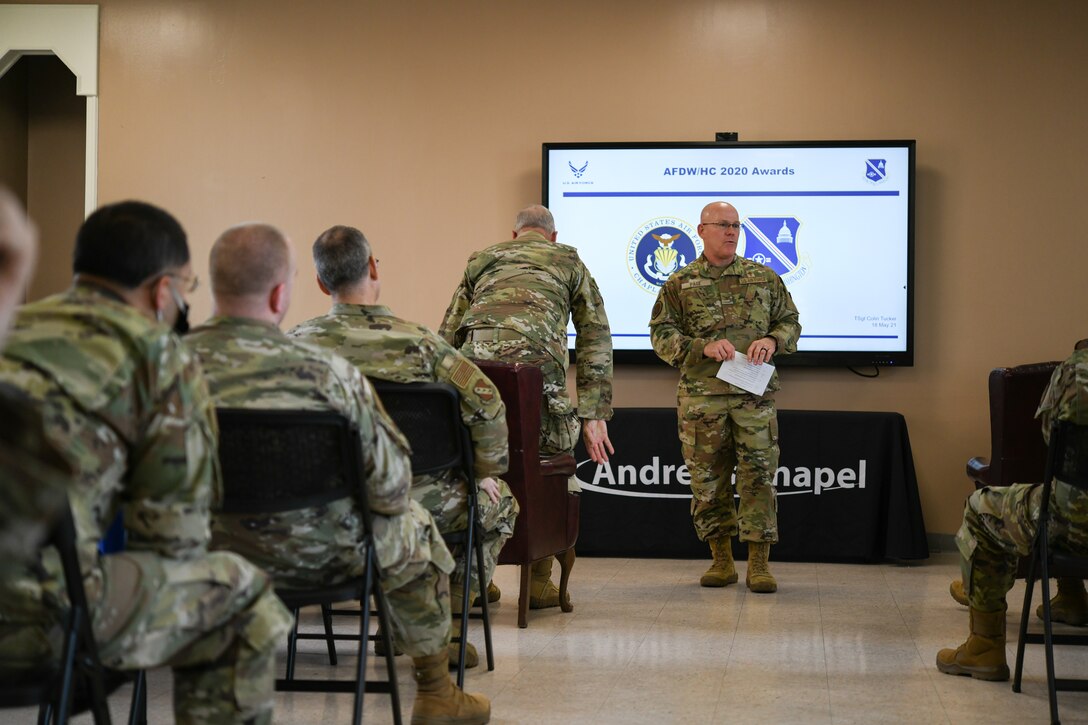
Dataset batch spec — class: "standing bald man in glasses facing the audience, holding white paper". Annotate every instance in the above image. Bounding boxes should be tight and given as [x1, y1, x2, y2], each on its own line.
[650, 201, 801, 592]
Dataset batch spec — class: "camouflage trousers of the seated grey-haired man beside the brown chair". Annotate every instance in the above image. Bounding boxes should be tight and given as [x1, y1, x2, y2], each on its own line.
[411, 472, 518, 598]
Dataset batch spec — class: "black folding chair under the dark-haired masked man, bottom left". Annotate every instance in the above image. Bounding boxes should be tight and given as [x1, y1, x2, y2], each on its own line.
[0, 505, 111, 725]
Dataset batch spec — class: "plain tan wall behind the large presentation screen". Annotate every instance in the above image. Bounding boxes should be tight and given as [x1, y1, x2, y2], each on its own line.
[10, 0, 1088, 533]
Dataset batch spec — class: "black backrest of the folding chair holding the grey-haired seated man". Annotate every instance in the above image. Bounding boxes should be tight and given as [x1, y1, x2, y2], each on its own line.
[371, 378, 475, 483]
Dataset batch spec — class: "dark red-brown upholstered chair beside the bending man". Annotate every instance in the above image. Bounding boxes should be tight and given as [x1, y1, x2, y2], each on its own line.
[475, 360, 579, 627]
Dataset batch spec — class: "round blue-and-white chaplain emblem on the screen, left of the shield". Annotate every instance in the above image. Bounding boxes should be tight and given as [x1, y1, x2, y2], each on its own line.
[627, 217, 703, 295]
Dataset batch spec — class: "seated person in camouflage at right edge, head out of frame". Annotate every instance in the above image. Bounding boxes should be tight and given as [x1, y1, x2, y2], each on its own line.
[937, 348, 1088, 681]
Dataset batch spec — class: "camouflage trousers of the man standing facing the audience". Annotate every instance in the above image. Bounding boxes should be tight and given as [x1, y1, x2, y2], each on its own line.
[678, 394, 778, 543]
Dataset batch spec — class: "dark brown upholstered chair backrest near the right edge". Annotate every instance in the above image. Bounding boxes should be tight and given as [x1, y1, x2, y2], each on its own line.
[987, 361, 1058, 486]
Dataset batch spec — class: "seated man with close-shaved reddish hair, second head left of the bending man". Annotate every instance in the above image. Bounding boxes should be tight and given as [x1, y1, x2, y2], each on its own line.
[185, 224, 491, 723]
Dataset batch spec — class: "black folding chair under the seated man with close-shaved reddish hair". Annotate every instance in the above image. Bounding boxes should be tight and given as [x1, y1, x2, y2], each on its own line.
[218, 408, 400, 725]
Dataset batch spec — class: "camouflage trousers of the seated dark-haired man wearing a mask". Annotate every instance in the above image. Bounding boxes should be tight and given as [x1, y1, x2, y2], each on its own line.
[0, 552, 292, 724]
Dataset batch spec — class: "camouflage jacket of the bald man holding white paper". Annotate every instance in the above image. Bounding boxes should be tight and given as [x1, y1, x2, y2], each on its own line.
[650, 256, 801, 397]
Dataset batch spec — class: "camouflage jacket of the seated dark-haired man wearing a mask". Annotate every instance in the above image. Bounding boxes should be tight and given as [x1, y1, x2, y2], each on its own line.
[0, 283, 220, 622]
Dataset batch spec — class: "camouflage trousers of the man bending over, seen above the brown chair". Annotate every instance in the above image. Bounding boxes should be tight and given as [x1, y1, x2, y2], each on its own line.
[461, 340, 582, 456]
